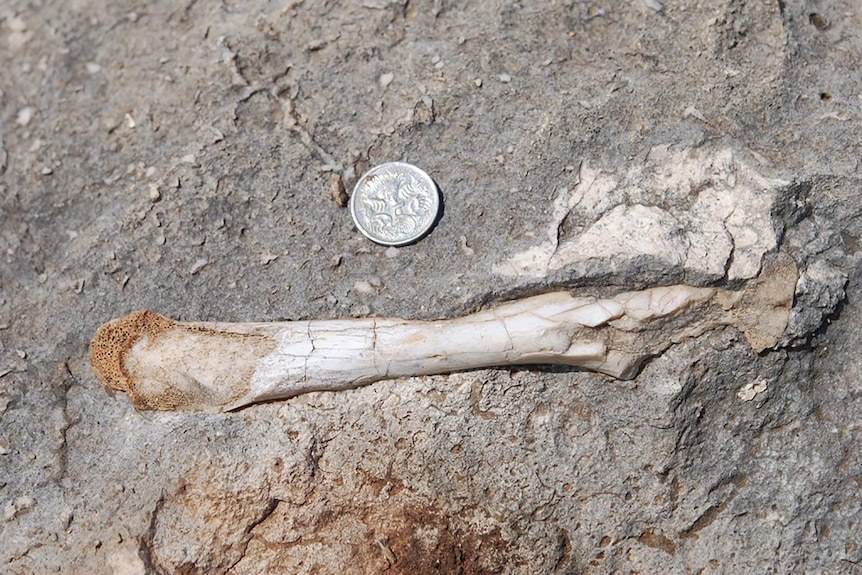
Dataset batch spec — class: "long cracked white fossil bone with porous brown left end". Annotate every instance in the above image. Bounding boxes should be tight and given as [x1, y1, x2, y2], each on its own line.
[91, 256, 796, 411]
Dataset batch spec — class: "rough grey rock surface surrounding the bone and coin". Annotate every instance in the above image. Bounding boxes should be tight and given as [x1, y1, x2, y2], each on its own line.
[0, 0, 862, 575]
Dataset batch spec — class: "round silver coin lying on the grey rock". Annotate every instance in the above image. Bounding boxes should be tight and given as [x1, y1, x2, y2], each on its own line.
[350, 162, 440, 246]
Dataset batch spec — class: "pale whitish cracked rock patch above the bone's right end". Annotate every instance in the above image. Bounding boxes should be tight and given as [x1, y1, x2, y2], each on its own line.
[496, 144, 788, 282]
